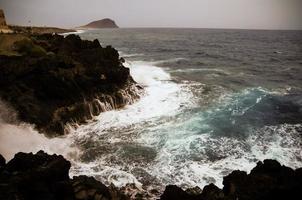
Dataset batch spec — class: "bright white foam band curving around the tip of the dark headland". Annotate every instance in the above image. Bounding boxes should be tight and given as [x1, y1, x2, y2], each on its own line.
[69, 62, 192, 135]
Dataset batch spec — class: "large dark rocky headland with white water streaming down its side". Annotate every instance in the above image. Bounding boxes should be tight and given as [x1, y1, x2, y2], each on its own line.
[0, 35, 139, 135]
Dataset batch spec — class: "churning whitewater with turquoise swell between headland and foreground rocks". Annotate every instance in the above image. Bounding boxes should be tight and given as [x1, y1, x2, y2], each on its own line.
[71, 59, 302, 190]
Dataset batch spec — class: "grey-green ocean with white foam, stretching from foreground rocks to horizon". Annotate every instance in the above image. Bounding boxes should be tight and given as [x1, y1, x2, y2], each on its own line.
[29, 29, 302, 195]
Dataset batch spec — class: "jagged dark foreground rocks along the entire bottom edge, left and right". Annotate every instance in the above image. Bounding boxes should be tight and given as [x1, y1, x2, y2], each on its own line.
[0, 151, 302, 200]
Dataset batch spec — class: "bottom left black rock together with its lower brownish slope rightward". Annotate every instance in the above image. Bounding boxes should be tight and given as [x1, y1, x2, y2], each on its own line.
[0, 151, 128, 200]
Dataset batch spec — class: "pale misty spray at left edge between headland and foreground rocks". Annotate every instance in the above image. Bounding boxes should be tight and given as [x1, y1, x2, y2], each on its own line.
[0, 101, 79, 160]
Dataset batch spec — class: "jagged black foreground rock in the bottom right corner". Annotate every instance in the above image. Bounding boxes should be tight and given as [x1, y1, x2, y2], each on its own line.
[161, 160, 302, 200]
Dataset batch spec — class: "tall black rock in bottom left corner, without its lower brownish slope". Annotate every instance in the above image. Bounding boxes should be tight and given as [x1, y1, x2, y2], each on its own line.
[0, 151, 73, 200]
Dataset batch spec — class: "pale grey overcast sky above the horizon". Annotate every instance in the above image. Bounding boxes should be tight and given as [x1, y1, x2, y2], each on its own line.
[0, 0, 302, 29]
